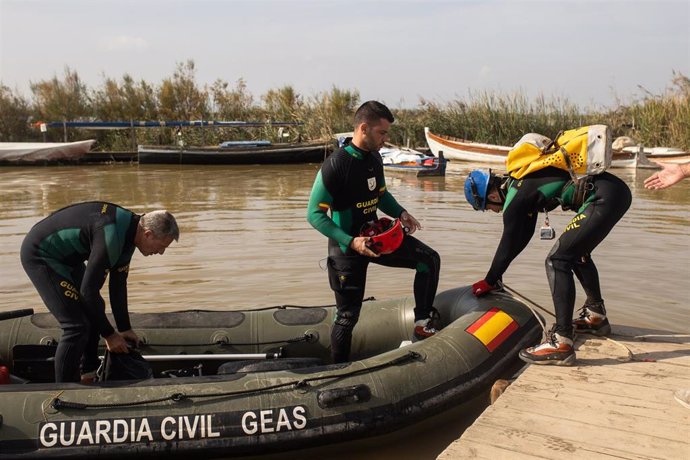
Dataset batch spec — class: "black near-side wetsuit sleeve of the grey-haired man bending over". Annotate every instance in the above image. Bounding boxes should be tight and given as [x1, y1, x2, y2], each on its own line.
[80, 231, 115, 337]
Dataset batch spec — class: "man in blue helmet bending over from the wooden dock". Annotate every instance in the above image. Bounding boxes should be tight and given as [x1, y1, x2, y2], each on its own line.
[465, 167, 632, 365]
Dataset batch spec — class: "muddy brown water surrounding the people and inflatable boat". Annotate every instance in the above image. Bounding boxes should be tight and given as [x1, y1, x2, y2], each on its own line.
[0, 164, 690, 458]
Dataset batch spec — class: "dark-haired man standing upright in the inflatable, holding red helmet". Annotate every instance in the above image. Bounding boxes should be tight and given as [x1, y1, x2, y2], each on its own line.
[307, 101, 441, 363]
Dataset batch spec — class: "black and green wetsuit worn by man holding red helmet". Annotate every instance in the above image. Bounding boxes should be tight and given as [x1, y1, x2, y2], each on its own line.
[307, 144, 441, 362]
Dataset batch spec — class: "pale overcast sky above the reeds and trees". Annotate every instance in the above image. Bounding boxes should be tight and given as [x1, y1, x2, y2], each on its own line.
[0, 0, 690, 107]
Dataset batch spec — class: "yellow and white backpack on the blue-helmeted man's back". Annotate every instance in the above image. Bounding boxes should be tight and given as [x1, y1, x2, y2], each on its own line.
[506, 125, 612, 179]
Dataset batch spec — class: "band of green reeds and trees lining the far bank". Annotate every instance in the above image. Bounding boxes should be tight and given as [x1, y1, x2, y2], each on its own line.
[0, 60, 690, 151]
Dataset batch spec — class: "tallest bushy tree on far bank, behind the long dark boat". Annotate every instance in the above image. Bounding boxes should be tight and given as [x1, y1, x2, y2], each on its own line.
[158, 59, 210, 120]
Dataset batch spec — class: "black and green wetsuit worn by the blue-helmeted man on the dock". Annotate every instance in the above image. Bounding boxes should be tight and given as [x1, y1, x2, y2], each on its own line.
[486, 167, 632, 336]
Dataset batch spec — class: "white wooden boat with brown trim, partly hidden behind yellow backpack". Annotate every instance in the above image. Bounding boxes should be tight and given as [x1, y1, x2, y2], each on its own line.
[424, 127, 690, 169]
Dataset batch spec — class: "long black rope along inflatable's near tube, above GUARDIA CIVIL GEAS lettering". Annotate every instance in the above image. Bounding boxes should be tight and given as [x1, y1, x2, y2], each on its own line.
[51, 351, 423, 410]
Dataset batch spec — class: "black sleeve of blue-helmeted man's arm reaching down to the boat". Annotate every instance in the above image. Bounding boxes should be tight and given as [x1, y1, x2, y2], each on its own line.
[486, 198, 538, 286]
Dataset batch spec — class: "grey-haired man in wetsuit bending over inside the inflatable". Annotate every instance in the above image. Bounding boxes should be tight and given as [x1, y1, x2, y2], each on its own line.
[21, 202, 180, 383]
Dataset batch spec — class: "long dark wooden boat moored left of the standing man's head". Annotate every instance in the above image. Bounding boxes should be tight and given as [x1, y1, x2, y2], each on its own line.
[138, 141, 332, 165]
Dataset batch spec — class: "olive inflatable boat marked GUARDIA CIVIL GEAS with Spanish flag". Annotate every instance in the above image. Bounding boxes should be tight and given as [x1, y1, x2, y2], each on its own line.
[0, 287, 541, 459]
